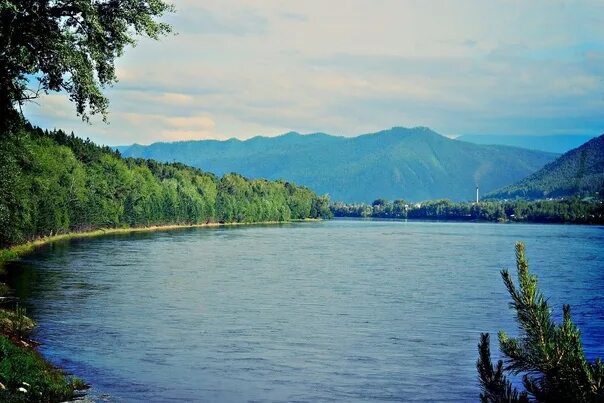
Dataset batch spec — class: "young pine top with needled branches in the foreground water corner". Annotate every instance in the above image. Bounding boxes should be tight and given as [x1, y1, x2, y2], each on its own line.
[476, 242, 604, 402]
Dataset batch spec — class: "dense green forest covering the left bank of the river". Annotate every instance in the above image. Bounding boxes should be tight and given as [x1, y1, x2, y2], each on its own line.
[0, 124, 330, 247]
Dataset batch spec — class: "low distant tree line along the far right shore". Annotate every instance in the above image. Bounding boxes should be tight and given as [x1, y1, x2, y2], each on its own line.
[331, 198, 604, 224]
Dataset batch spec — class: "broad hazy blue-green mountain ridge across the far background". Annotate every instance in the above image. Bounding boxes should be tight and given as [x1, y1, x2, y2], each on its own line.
[120, 127, 557, 202]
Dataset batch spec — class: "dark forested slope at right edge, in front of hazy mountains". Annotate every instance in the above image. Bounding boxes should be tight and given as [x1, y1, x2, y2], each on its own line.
[488, 134, 604, 199]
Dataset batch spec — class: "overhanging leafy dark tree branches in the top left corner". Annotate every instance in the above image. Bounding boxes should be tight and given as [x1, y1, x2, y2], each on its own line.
[0, 0, 173, 132]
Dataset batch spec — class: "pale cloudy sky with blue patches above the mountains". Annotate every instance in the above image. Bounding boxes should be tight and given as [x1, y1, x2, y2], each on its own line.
[25, 0, 604, 145]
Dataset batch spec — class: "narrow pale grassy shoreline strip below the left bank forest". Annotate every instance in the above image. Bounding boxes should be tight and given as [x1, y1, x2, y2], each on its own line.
[0, 218, 321, 268]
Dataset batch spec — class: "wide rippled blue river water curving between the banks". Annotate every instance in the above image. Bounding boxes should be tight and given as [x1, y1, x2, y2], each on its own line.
[5, 220, 604, 402]
